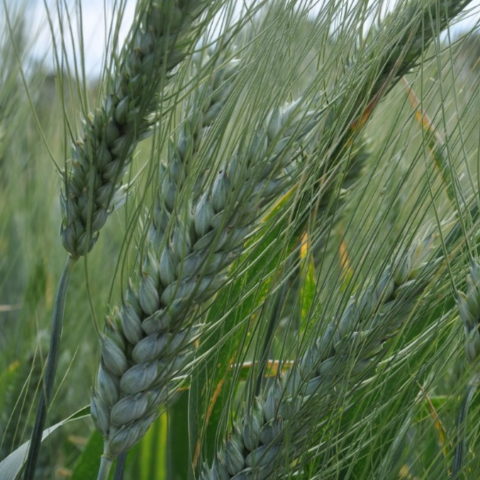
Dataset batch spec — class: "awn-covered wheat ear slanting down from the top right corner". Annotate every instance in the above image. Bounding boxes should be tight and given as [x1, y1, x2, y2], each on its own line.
[296, 0, 472, 240]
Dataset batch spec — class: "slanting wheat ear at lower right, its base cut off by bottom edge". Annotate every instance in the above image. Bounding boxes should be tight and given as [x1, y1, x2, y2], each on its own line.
[199, 239, 436, 480]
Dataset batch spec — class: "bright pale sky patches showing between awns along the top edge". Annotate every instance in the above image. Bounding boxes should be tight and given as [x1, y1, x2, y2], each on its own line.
[18, 0, 480, 76]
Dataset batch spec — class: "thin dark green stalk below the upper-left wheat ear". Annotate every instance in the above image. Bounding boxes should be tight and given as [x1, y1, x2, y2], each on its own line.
[24, 255, 76, 480]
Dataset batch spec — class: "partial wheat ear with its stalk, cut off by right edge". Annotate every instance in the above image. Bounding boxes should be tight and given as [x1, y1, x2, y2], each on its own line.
[451, 258, 480, 479]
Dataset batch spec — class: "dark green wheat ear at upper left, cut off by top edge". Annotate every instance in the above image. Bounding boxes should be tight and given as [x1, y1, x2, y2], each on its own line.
[61, 0, 218, 258]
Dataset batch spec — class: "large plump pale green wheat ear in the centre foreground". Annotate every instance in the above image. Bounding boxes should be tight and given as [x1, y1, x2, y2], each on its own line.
[91, 82, 326, 471]
